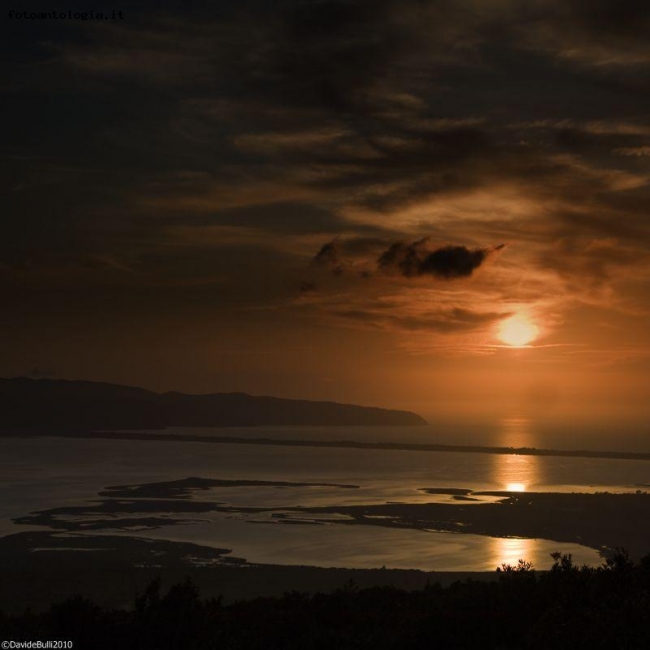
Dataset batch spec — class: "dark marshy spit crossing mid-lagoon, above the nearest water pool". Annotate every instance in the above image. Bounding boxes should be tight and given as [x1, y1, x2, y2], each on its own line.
[13, 477, 650, 557]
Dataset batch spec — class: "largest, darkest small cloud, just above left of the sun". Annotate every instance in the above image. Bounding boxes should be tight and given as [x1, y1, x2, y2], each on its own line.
[377, 239, 505, 280]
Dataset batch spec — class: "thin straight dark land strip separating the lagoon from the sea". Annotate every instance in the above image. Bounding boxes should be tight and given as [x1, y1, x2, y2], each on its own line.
[33, 431, 650, 460]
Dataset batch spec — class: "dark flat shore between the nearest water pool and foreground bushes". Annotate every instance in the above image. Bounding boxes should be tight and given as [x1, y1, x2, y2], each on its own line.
[0, 531, 498, 613]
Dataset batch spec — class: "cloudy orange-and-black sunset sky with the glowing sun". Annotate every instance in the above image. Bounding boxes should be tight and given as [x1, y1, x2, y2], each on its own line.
[0, 0, 650, 418]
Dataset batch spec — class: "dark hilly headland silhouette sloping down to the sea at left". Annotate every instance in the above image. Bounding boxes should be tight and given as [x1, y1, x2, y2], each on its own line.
[0, 377, 426, 432]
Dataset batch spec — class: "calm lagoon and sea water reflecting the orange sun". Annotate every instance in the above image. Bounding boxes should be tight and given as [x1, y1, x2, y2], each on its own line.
[0, 418, 650, 571]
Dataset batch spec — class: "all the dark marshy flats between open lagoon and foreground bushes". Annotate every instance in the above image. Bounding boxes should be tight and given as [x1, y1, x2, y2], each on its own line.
[0, 477, 650, 611]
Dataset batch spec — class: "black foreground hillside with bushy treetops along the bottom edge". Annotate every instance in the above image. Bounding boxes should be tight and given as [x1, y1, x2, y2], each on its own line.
[0, 553, 650, 650]
